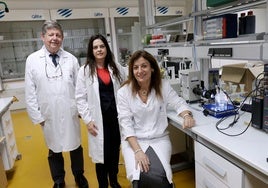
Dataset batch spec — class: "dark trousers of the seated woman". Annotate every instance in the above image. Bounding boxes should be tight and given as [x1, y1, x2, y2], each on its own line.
[132, 147, 173, 188]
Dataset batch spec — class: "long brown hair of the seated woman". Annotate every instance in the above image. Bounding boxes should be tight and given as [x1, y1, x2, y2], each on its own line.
[123, 50, 163, 99]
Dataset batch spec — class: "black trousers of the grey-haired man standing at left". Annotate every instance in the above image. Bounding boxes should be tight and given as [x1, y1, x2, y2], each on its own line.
[48, 145, 84, 183]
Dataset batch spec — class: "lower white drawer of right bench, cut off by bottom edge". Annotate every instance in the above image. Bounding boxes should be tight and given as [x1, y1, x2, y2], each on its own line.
[195, 162, 228, 188]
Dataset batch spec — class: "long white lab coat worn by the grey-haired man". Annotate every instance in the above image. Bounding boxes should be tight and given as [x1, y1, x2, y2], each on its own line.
[25, 46, 81, 152]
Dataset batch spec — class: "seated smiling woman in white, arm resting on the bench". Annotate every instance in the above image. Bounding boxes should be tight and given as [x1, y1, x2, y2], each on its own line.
[117, 50, 195, 188]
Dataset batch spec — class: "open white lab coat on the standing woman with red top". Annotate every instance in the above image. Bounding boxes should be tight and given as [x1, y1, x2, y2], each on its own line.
[75, 65, 126, 163]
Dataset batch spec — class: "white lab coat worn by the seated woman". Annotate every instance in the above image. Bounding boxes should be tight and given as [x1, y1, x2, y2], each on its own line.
[117, 80, 188, 183]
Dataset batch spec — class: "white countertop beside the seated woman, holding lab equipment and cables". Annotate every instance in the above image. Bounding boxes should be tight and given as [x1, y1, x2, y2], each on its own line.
[168, 105, 268, 183]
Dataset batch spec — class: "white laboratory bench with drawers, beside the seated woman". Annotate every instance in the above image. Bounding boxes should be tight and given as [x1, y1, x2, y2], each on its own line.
[168, 104, 268, 188]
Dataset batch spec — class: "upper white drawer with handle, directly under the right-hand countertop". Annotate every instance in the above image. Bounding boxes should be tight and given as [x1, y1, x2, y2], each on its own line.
[195, 141, 243, 188]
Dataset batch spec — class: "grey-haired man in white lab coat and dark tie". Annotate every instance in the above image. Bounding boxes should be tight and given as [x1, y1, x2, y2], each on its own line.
[25, 21, 88, 188]
